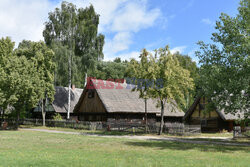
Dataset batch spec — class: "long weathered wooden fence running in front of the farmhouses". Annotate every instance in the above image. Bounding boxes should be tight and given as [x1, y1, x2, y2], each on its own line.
[1, 119, 201, 135]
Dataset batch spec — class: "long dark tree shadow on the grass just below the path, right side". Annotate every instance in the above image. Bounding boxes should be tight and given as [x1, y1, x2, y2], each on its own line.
[125, 140, 250, 153]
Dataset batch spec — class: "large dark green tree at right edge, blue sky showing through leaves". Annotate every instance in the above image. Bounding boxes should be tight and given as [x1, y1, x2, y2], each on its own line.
[196, 0, 250, 116]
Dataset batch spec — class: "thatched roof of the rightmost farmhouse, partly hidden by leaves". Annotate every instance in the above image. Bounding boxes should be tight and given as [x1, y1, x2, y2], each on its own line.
[183, 97, 249, 121]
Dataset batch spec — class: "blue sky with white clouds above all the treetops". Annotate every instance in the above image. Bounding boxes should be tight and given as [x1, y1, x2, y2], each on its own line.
[0, 0, 239, 61]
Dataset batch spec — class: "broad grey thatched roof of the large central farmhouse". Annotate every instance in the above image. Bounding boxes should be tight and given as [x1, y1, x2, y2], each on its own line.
[74, 79, 184, 117]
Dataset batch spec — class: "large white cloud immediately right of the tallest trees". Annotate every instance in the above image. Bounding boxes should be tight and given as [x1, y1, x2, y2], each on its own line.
[82, 0, 161, 59]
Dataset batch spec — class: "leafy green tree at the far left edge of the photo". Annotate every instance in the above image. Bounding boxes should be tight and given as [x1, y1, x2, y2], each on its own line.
[0, 38, 40, 127]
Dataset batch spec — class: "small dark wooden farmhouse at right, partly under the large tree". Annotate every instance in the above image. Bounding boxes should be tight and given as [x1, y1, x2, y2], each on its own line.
[183, 97, 247, 132]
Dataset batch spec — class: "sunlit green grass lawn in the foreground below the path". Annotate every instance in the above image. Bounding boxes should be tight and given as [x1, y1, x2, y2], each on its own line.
[0, 131, 250, 167]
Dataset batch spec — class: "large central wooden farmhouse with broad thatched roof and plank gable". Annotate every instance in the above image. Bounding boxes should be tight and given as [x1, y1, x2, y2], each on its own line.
[74, 79, 184, 122]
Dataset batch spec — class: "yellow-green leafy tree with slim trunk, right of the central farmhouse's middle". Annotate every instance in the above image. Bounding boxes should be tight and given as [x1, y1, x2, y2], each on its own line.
[149, 46, 194, 135]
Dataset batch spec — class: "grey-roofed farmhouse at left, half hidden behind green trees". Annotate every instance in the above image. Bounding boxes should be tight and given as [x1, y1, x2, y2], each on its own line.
[33, 86, 83, 119]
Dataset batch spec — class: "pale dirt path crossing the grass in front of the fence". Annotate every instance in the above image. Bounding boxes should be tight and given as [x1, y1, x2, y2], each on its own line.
[20, 128, 250, 147]
